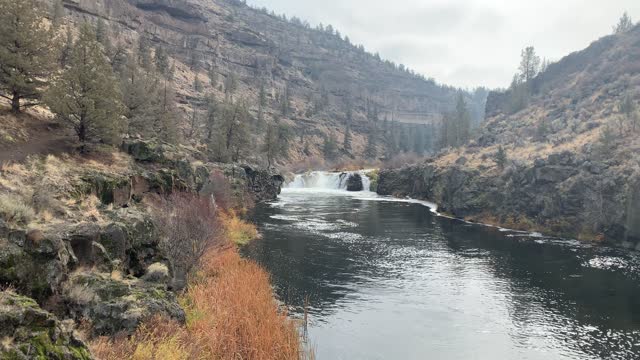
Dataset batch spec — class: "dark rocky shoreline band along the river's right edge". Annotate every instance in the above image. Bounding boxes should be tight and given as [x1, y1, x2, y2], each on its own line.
[377, 152, 640, 248]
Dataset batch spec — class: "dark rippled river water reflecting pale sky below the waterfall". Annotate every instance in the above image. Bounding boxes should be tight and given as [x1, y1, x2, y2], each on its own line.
[244, 189, 640, 360]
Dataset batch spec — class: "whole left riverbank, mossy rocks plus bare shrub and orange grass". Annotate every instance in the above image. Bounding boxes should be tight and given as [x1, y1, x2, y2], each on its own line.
[0, 136, 306, 359]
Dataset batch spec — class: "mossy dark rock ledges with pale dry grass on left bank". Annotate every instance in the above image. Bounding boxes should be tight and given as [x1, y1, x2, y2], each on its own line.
[0, 140, 283, 359]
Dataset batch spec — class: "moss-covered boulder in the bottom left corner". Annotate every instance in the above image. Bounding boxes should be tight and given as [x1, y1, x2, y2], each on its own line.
[0, 291, 91, 360]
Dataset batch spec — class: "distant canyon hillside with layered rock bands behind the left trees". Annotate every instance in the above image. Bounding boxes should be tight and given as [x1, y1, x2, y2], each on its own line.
[46, 0, 486, 162]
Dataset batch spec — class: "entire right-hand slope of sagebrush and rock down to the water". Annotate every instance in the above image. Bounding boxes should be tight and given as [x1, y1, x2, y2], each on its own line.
[379, 26, 640, 247]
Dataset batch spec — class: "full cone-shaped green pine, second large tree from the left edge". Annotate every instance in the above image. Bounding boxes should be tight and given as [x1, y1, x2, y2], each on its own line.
[46, 24, 126, 144]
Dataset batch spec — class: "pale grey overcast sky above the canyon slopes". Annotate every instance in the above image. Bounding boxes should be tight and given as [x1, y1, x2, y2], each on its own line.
[248, 0, 640, 88]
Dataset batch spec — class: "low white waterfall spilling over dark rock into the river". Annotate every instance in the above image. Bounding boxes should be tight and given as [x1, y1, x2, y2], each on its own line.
[284, 170, 371, 191]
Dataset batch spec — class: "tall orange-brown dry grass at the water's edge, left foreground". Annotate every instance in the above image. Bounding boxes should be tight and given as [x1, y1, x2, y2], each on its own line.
[91, 248, 313, 360]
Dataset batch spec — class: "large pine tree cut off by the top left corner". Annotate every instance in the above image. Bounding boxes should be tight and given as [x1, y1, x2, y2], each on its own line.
[0, 0, 55, 113]
